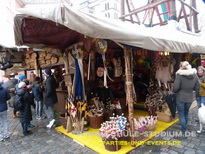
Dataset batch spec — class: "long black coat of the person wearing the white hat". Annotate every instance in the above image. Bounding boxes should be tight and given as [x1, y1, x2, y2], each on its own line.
[17, 88, 33, 123]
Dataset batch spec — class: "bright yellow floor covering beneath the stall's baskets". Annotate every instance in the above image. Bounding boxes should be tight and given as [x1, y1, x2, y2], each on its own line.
[56, 110, 178, 154]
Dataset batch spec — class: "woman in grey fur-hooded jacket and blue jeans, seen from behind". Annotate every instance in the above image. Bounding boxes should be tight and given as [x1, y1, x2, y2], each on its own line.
[173, 61, 200, 136]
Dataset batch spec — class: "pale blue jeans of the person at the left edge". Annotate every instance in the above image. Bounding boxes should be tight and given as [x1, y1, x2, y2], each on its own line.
[0, 111, 9, 139]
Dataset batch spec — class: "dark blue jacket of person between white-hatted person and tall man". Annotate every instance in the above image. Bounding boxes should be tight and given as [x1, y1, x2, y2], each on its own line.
[32, 81, 43, 102]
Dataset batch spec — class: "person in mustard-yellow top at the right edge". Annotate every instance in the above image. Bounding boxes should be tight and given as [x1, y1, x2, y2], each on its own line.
[196, 66, 205, 108]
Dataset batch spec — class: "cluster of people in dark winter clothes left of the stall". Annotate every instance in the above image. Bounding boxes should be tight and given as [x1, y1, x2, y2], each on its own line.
[0, 69, 57, 142]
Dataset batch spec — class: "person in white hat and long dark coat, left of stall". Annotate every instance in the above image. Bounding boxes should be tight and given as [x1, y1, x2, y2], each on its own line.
[15, 82, 33, 136]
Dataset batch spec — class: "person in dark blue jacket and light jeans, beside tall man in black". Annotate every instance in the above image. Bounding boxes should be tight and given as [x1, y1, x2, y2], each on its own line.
[32, 76, 43, 120]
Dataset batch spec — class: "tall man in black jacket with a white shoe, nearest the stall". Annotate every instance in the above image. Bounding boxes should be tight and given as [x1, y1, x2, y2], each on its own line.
[43, 69, 57, 128]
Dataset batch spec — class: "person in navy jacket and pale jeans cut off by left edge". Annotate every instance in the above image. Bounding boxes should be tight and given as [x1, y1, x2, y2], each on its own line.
[0, 83, 11, 142]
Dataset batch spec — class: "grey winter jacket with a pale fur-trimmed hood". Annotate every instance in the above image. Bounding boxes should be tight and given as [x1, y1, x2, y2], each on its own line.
[173, 68, 200, 103]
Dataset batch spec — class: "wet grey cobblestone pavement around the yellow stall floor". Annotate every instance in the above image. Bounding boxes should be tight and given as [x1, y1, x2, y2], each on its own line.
[0, 102, 205, 154]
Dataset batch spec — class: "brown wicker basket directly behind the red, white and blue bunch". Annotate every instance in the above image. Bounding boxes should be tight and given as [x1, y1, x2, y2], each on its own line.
[88, 115, 103, 129]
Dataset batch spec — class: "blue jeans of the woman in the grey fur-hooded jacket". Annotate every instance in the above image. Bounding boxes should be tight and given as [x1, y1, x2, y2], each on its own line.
[176, 101, 192, 135]
